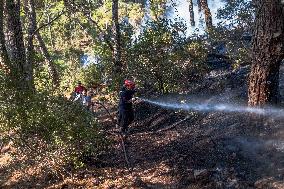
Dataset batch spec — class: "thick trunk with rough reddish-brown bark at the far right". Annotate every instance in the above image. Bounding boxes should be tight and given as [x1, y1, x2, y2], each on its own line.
[248, 0, 284, 106]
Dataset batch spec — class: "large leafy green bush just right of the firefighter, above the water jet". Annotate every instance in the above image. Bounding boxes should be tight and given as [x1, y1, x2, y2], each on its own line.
[128, 18, 204, 93]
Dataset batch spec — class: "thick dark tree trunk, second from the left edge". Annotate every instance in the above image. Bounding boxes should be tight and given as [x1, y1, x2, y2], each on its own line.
[6, 0, 33, 90]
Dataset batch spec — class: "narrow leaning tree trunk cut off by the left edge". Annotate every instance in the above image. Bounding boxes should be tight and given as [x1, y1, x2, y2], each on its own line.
[0, 0, 10, 69]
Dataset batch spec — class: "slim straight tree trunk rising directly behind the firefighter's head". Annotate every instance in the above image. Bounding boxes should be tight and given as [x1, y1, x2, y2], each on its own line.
[112, 0, 122, 77]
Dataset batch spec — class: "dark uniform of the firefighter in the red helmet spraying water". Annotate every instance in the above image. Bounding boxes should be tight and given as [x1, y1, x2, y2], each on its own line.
[118, 87, 136, 133]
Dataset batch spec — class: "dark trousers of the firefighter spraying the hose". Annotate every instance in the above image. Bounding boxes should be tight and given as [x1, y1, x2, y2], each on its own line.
[118, 109, 134, 132]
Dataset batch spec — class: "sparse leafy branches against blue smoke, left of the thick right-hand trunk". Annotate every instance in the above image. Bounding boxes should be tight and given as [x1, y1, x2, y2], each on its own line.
[195, 0, 255, 68]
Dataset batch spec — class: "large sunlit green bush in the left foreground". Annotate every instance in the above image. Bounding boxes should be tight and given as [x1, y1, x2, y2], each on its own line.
[0, 82, 107, 170]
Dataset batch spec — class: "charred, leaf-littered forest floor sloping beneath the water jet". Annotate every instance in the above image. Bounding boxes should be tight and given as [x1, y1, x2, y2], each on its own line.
[0, 64, 284, 189]
